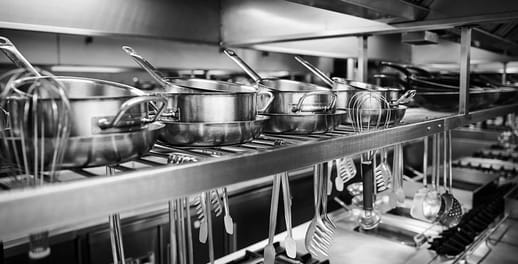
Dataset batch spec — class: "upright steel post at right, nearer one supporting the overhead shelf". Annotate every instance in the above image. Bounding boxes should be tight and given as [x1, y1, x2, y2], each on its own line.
[459, 26, 471, 115]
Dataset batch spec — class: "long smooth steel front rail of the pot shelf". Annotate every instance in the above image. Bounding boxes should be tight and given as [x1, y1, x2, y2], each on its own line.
[0, 104, 518, 240]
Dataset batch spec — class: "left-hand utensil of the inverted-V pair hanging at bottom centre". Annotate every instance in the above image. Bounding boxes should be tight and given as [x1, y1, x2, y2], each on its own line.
[264, 174, 281, 264]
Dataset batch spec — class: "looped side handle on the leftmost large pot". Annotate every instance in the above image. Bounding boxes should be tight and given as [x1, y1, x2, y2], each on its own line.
[97, 96, 167, 129]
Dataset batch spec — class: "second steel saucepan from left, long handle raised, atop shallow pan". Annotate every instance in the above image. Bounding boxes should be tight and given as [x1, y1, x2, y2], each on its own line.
[122, 46, 273, 123]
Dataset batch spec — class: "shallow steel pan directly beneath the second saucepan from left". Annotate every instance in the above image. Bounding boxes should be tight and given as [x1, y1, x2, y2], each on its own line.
[159, 115, 268, 147]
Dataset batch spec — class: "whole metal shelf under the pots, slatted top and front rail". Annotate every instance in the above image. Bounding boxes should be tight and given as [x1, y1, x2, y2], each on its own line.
[0, 104, 518, 241]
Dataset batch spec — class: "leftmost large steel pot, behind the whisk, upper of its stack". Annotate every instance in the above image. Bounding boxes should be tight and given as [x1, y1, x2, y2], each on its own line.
[6, 76, 166, 137]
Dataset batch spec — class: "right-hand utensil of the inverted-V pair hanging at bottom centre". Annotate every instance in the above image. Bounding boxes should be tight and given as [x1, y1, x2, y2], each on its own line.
[281, 172, 297, 258]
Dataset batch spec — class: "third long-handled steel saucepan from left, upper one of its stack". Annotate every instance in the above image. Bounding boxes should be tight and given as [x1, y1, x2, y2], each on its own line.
[224, 49, 336, 114]
